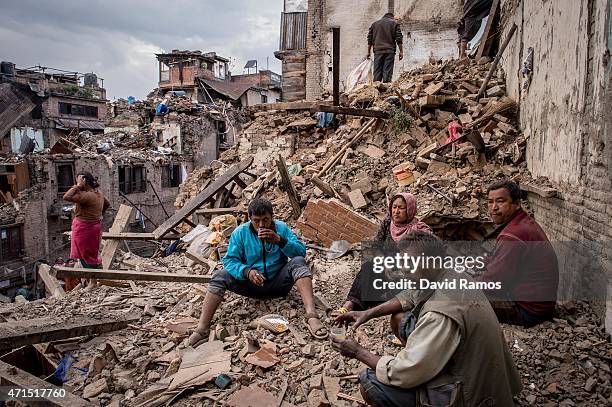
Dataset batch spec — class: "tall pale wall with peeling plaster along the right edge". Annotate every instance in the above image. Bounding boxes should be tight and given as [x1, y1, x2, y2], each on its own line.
[501, 0, 612, 332]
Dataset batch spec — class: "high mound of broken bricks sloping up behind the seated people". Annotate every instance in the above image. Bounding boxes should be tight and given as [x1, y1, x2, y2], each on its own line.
[177, 58, 545, 240]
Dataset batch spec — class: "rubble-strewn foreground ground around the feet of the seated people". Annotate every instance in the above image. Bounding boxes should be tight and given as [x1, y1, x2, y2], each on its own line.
[0, 256, 612, 407]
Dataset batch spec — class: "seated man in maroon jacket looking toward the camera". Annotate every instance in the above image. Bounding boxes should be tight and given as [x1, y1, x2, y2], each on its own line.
[482, 180, 559, 327]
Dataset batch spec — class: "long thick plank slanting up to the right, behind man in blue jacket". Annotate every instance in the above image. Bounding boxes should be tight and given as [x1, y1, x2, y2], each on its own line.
[153, 157, 253, 239]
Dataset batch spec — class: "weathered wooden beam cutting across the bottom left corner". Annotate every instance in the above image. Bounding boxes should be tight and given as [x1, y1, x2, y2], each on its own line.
[0, 360, 93, 407]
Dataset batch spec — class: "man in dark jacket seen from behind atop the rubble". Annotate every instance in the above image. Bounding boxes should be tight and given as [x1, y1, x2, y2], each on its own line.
[367, 13, 404, 83]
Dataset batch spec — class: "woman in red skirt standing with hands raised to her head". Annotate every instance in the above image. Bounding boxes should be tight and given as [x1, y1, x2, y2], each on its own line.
[64, 171, 110, 291]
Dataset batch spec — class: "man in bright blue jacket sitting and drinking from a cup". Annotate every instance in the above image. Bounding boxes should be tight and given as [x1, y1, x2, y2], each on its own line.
[189, 198, 327, 346]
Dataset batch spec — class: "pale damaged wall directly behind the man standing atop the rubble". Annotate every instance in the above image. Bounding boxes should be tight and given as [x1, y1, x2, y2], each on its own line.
[306, 0, 463, 100]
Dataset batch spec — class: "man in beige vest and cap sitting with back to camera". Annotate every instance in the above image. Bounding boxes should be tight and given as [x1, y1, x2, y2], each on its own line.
[333, 231, 521, 407]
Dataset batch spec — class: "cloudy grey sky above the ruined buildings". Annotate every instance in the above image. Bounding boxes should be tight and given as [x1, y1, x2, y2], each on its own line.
[0, 0, 283, 100]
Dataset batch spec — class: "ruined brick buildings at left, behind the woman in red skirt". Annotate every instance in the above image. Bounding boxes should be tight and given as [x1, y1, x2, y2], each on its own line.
[0, 62, 249, 295]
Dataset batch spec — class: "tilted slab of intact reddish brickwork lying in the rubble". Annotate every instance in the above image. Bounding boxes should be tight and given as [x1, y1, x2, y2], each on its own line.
[297, 199, 378, 246]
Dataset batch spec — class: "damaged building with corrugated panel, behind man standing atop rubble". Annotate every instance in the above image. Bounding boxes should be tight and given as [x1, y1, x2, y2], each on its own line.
[275, 0, 463, 102]
